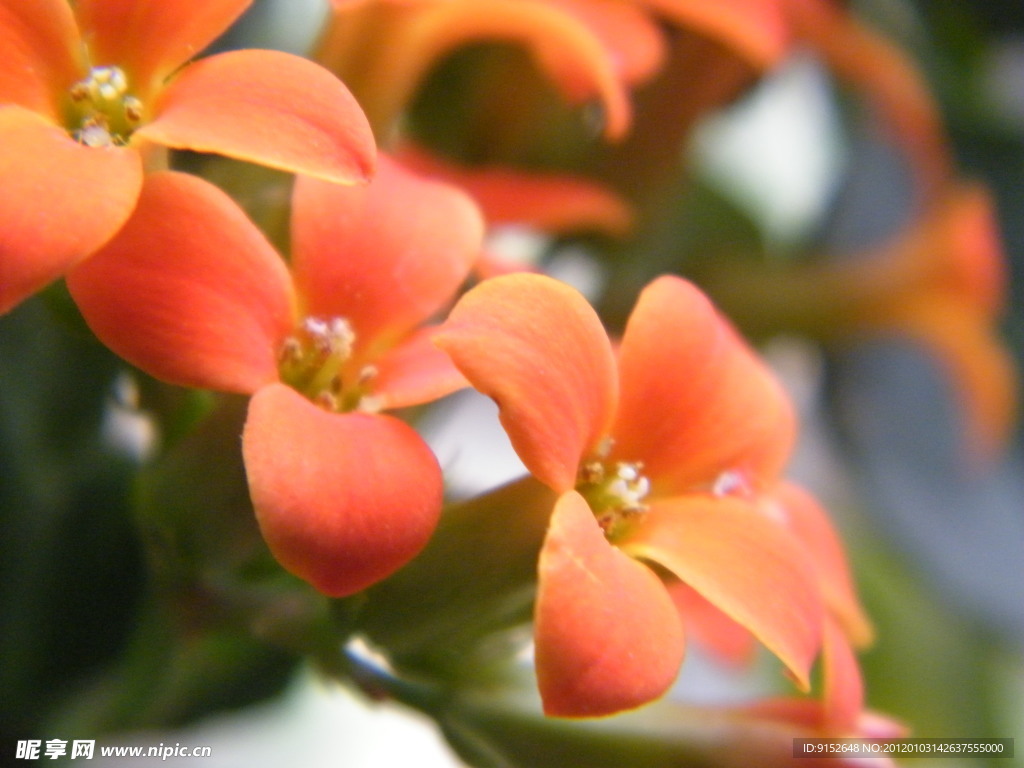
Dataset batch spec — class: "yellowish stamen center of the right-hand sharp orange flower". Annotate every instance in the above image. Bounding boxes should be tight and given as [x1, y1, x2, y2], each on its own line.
[575, 446, 650, 538]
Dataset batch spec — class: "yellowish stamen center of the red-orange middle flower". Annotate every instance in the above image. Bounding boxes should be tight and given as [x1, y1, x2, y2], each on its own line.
[278, 317, 380, 413]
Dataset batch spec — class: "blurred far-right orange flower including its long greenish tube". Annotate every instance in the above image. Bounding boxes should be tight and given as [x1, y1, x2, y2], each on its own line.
[705, 182, 1019, 461]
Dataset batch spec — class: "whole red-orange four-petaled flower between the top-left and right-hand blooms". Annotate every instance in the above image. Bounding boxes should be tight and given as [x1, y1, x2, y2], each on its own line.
[68, 158, 482, 596]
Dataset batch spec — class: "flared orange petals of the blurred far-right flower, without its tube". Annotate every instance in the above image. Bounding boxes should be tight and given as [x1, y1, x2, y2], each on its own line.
[847, 182, 1018, 459]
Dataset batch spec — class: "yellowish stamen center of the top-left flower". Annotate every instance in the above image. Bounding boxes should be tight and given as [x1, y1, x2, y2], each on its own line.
[69, 67, 143, 146]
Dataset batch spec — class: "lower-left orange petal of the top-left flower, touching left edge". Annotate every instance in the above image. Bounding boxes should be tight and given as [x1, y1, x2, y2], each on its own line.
[0, 106, 142, 312]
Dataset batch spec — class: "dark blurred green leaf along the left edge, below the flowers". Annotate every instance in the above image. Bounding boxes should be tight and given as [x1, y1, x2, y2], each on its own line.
[0, 299, 145, 728]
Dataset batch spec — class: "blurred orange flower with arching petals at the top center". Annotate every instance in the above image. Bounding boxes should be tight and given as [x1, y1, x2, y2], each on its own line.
[316, 0, 662, 136]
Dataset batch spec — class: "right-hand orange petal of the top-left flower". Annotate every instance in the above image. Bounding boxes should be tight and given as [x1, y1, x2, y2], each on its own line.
[135, 50, 376, 183]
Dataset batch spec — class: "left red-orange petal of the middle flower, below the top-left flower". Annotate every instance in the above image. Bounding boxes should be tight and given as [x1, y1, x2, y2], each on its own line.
[68, 171, 294, 392]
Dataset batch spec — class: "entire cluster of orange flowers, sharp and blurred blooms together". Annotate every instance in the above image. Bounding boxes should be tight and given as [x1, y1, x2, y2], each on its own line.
[0, 0, 1011, 757]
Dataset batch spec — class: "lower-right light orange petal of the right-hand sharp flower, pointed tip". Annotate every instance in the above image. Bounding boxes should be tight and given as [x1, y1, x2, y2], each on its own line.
[615, 495, 824, 688]
